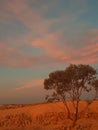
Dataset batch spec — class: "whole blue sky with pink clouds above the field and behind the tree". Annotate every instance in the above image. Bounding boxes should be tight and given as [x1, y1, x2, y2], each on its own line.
[0, 0, 98, 104]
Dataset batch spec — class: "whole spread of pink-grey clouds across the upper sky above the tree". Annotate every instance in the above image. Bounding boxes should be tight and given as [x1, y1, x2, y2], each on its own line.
[0, 0, 98, 67]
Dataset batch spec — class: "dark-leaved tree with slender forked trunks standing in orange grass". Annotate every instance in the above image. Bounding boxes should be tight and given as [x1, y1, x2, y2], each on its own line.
[44, 64, 98, 123]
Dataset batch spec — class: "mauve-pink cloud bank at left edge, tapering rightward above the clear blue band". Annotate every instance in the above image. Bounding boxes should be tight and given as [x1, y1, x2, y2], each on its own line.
[0, 41, 62, 68]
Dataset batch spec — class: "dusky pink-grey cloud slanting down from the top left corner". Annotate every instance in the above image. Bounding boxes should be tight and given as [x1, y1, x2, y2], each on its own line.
[0, 0, 80, 34]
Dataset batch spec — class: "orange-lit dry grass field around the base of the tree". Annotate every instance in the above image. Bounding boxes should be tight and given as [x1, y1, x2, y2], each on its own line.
[0, 101, 98, 130]
